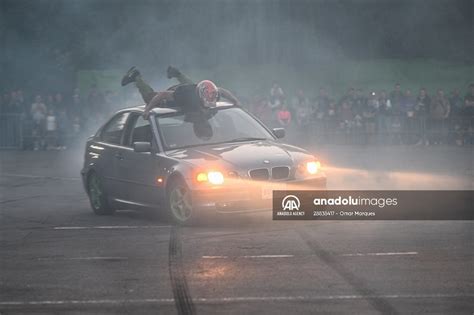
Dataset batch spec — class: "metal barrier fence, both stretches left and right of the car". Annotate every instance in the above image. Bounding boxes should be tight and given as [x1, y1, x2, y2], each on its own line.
[0, 114, 474, 150]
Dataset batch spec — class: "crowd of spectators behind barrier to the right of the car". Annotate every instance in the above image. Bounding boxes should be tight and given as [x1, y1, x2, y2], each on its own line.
[249, 82, 474, 145]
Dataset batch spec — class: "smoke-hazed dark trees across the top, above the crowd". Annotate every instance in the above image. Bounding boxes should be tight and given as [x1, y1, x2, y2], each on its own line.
[0, 0, 474, 89]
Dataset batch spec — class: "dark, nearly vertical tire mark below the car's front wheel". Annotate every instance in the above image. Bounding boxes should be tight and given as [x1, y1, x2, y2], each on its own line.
[168, 226, 196, 315]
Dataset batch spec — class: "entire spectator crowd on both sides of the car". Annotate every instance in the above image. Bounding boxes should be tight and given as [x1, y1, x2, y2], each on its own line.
[0, 82, 474, 150]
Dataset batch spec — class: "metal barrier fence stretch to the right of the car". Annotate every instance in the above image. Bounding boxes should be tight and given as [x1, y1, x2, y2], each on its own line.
[287, 116, 474, 146]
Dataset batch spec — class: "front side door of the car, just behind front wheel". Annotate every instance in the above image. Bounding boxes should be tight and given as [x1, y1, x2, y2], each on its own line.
[119, 113, 160, 206]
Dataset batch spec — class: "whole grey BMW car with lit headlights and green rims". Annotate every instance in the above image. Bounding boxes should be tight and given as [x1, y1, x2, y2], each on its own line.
[81, 103, 326, 224]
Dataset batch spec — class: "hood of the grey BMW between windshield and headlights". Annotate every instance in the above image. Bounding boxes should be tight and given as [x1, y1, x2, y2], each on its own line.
[167, 140, 311, 169]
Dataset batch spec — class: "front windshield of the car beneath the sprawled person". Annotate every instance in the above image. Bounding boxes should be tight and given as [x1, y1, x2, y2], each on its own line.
[156, 107, 274, 150]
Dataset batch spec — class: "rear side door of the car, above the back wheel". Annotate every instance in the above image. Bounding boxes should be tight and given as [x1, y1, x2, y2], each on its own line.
[97, 112, 130, 199]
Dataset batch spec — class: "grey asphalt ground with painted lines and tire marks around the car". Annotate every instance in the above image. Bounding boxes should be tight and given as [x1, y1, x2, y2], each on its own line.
[0, 146, 474, 315]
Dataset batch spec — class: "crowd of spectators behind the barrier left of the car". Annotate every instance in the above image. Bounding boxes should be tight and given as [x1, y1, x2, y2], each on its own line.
[0, 86, 119, 150]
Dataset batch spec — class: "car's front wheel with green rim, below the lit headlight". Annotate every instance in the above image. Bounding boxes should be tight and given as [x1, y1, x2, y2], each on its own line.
[166, 179, 196, 225]
